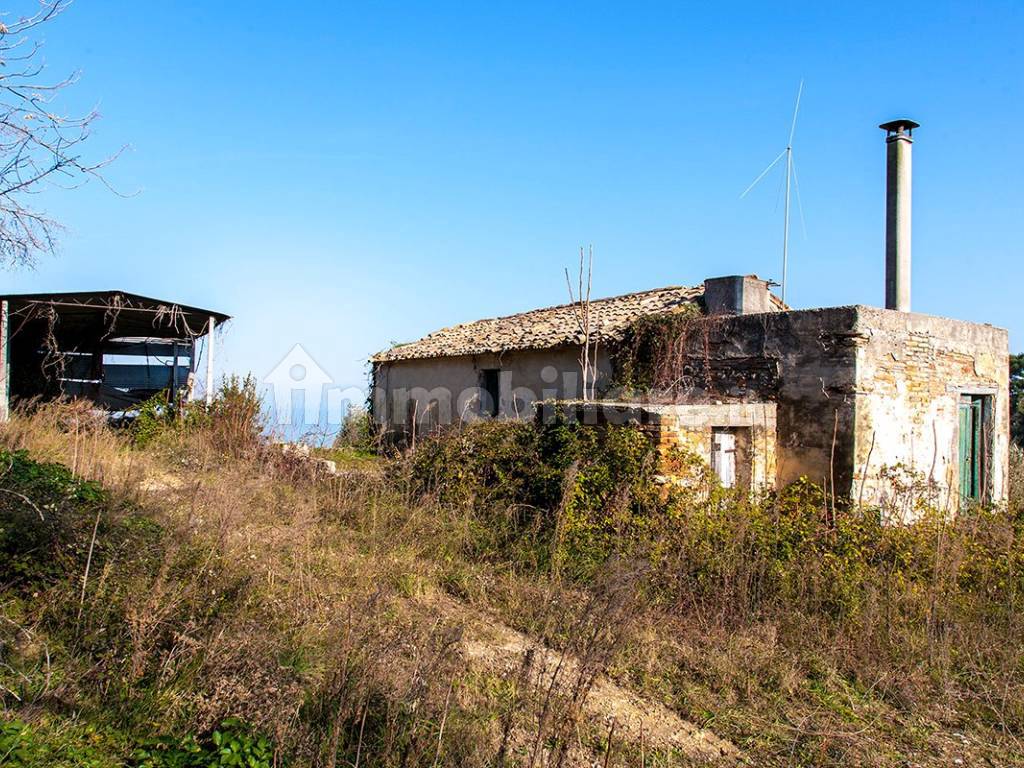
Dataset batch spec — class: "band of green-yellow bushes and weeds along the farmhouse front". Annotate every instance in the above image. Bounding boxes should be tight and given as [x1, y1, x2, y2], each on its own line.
[413, 424, 1024, 734]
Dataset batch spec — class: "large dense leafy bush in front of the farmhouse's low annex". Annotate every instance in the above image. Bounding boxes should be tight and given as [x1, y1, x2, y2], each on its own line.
[411, 419, 657, 578]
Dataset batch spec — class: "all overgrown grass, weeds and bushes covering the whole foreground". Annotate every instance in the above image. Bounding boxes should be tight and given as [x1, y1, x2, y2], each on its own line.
[0, 397, 1024, 768]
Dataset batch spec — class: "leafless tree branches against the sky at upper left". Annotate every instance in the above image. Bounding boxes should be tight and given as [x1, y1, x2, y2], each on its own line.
[0, 0, 120, 266]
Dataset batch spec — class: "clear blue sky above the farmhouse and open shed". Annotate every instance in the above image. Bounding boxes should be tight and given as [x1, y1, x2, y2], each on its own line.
[4, 0, 1024, 397]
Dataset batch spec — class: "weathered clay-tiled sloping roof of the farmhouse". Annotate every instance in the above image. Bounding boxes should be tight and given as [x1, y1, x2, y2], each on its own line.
[373, 285, 703, 362]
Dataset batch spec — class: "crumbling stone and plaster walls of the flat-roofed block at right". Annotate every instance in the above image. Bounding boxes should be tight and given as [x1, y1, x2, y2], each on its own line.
[614, 306, 1010, 514]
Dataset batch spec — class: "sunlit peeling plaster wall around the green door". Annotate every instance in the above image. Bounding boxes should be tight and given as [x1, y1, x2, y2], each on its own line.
[854, 307, 1010, 517]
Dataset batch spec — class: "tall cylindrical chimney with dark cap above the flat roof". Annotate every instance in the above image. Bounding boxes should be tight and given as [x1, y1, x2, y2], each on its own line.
[879, 119, 919, 312]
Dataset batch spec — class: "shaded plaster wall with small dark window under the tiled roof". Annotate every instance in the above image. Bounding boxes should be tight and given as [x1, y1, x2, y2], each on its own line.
[373, 346, 611, 433]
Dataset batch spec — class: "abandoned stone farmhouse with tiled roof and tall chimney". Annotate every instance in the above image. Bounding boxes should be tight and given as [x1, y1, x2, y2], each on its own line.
[372, 121, 1010, 508]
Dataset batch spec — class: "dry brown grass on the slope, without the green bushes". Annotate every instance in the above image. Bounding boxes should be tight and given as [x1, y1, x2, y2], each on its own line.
[0, 406, 1024, 766]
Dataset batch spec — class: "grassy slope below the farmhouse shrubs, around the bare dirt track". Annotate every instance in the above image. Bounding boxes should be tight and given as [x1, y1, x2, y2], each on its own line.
[0, 410, 1024, 766]
